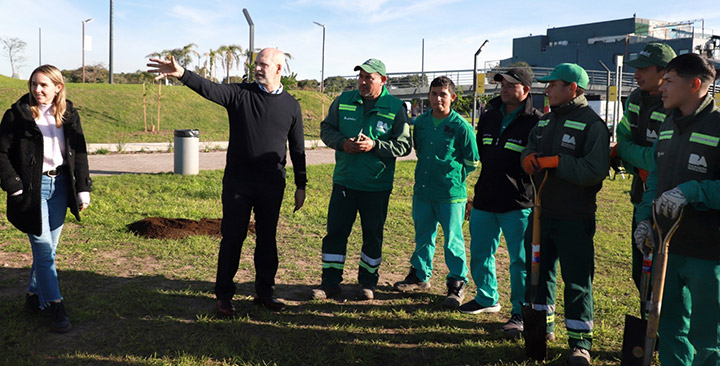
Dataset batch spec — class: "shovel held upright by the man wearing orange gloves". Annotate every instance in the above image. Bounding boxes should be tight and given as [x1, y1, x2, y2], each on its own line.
[522, 171, 548, 361]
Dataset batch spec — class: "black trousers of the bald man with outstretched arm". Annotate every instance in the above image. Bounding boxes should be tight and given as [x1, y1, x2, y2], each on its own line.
[215, 178, 285, 299]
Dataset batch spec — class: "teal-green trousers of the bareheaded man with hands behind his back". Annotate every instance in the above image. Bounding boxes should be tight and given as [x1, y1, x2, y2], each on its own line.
[410, 196, 468, 283]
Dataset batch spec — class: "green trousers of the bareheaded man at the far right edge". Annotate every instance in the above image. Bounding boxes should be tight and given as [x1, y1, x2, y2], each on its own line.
[658, 254, 720, 366]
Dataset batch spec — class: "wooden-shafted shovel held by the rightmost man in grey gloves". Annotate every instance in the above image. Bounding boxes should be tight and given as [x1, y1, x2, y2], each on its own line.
[621, 204, 684, 366]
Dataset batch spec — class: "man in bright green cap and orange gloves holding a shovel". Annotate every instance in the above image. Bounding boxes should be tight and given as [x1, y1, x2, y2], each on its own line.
[521, 63, 610, 365]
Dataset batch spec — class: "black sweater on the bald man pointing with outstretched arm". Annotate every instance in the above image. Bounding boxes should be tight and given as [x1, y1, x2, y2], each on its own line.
[180, 70, 307, 188]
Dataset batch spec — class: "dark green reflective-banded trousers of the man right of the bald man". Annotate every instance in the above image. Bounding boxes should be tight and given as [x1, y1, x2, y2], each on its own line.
[322, 184, 390, 287]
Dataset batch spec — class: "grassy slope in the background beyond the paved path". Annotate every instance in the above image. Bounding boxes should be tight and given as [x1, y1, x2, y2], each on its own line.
[0, 75, 332, 144]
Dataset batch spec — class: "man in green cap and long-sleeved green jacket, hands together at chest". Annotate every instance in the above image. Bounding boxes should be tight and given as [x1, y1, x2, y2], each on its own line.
[312, 58, 412, 300]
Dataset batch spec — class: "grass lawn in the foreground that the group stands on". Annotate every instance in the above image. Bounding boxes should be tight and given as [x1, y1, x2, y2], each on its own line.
[0, 162, 638, 365]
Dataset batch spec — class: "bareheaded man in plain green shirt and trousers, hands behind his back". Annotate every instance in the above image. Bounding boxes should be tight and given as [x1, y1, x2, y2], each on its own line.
[395, 76, 479, 309]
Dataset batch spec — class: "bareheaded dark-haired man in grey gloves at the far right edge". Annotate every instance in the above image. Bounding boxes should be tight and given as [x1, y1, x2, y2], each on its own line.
[634, 53, 720, 365]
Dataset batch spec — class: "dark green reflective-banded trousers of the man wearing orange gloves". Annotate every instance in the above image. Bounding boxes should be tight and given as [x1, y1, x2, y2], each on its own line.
[525, 216, 595, 350]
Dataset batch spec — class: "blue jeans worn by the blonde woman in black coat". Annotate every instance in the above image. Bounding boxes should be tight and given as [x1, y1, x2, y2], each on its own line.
[27, 175, 68, 308]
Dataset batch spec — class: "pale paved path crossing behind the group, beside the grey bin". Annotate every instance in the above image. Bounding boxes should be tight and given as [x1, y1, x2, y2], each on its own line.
[88, 148, 416, 176]
